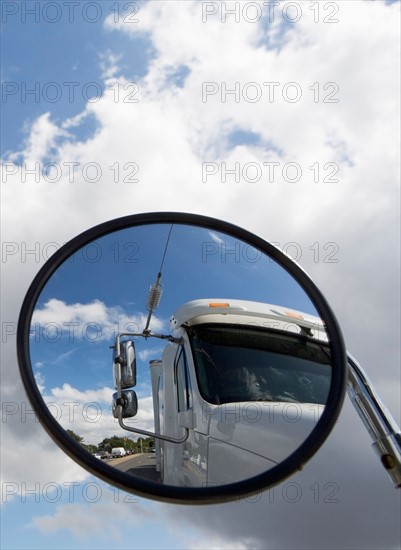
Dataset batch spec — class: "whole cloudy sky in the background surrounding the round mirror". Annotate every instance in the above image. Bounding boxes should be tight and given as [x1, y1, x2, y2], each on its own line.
[1, 0, 400, 550]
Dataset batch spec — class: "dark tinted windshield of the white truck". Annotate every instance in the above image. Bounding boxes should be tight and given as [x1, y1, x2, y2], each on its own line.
[188, 325, 331, 405]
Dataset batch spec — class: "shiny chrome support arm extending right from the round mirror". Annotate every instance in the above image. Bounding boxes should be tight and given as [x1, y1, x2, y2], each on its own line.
[347, 354, 401, 488]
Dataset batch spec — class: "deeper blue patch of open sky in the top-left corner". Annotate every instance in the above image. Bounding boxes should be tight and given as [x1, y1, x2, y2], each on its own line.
[1, 0, 152, 156]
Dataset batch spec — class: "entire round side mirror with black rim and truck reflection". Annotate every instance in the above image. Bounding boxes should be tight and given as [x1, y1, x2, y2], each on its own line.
[17, 212, 347, 504]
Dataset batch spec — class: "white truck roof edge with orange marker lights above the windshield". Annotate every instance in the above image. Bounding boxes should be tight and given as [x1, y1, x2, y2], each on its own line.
[170, 298, 328, 341]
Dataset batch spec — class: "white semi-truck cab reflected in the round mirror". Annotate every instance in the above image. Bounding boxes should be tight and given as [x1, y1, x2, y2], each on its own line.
[112, 299, 331, 487]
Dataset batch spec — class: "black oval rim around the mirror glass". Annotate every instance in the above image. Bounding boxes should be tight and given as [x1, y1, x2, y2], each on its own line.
[17, 212, 348, 504]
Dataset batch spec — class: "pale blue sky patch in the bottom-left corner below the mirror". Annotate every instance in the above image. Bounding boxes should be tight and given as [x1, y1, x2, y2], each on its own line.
[2, 488, 182, 550]
